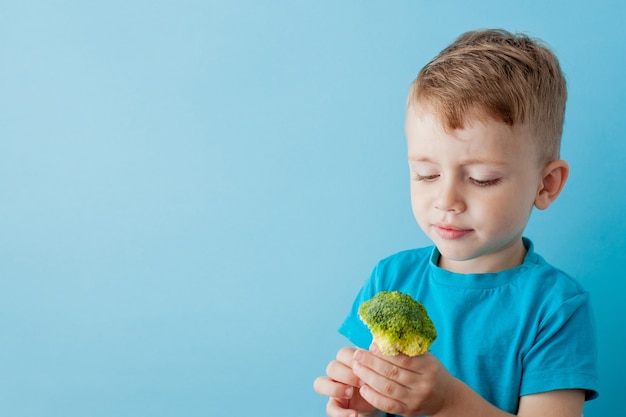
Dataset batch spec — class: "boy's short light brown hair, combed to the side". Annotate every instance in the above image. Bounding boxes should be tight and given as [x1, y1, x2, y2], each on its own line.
[409, 30, 567, 163]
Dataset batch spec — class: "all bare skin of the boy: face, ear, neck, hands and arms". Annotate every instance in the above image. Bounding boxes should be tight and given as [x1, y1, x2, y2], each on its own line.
[314, 103, 584, 417]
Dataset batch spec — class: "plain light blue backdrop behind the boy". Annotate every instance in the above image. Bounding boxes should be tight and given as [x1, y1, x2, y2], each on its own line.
[0, 0, 626, 417]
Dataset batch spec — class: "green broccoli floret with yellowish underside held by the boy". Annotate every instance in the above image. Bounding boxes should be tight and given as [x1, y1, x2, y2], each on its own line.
[359, 291, 437, 356]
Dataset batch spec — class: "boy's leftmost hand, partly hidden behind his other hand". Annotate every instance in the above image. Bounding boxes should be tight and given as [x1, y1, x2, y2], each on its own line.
[313, 347, 376, 417]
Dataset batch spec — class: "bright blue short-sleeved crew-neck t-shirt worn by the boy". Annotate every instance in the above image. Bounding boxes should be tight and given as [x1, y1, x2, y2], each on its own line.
[339, 238, 598, 413]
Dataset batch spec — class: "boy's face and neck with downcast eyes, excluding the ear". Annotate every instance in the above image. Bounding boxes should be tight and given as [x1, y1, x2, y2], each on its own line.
[406, 104, 542, 273]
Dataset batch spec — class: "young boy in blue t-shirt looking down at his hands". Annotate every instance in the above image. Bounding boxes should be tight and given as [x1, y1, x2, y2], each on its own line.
[314, 30, 598, 417]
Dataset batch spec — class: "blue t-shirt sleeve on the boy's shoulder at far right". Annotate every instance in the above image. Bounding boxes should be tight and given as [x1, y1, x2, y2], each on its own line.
[520, 292, 598, 400]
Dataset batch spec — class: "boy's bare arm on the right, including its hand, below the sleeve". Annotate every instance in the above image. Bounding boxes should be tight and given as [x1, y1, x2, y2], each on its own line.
[352, 348, 584, 417]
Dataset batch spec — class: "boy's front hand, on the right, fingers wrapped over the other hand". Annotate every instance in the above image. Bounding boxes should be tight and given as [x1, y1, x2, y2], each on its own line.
[352, 344, 455, 416]
